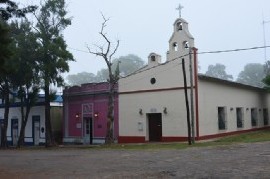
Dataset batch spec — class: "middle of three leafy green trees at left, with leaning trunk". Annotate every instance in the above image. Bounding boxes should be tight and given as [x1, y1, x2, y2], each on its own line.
[10, 20, 40, 147]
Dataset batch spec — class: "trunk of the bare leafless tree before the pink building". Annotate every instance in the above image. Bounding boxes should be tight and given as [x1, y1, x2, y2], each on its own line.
[105, 83, 114, 144]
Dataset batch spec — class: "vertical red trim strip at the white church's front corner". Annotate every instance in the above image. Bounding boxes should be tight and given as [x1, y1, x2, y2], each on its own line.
[193, 47, 200, 138]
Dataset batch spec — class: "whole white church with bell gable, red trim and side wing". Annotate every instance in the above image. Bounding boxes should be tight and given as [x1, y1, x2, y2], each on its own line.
[118, 15, 270, 143]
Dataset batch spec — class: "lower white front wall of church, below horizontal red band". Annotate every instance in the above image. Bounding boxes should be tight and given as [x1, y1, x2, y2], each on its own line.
[119, 90, 193, 140]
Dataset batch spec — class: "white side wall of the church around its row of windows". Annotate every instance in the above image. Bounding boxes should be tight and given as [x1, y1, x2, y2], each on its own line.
[199, 80, 270, 136]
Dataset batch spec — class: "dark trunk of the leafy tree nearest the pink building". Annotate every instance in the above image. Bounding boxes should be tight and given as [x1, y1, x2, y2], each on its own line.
[44, 80, 54, 147]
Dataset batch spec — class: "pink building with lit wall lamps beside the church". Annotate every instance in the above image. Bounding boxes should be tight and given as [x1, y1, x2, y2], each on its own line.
[63, 82, 119, 144]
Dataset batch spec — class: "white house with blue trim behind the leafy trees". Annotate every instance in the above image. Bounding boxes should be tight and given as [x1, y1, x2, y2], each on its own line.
[0, 95, 63, 146]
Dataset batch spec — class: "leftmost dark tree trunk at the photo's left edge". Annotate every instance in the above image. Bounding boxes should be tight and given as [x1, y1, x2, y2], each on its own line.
[1, 79, 10, 148]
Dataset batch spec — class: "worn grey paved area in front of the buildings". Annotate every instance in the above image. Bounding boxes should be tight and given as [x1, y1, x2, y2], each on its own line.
[0, 142, 270, 179]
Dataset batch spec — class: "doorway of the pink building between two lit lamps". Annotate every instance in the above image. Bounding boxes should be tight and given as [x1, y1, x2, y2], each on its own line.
[83, 117, 93, 144]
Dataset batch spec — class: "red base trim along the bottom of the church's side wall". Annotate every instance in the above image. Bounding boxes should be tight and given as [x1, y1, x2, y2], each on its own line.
[198, 126, 270, 140]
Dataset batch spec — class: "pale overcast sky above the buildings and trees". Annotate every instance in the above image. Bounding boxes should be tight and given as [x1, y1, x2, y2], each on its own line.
[22, 0, 270, 77]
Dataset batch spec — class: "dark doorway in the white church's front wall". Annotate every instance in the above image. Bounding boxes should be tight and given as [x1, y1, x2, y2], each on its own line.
[148, 113, 162, 142]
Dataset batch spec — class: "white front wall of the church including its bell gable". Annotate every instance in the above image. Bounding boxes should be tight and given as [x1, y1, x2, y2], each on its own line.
[119, 18, 194, 141]
